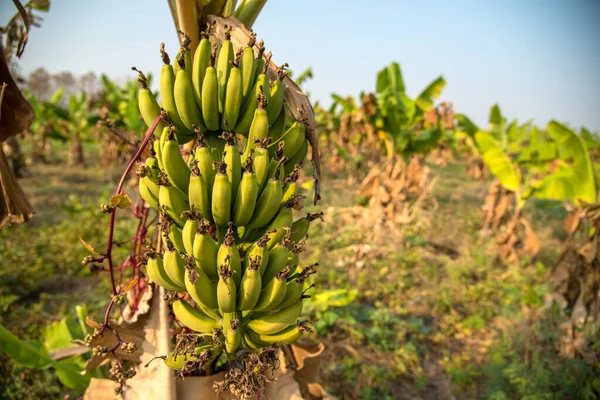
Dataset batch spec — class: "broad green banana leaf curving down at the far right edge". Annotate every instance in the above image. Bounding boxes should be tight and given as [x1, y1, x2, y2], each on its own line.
[547, 120, 597, 203]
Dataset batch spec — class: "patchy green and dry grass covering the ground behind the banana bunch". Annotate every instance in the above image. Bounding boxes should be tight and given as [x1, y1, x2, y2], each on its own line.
[0, 142, 600, 400]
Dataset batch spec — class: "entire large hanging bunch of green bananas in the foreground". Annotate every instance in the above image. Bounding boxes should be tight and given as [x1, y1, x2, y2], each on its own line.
[132, 24, 322, 369]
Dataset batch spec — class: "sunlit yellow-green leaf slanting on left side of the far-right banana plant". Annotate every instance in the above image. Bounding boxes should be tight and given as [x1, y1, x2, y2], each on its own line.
[475, 131, 521, 192]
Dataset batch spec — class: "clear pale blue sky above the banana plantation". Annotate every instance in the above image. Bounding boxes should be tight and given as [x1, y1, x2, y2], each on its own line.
[0, 0, 600, 130]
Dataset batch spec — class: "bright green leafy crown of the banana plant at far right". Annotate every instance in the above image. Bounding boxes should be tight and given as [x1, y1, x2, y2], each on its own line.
[457, 105, 596, 210]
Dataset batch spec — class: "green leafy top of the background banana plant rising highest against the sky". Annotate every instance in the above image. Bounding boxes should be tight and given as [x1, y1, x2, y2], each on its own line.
[372, 62, 446, 158]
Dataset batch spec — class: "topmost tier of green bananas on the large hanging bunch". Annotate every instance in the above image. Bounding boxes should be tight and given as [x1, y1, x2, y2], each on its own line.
[134, 27, 308, 167]
